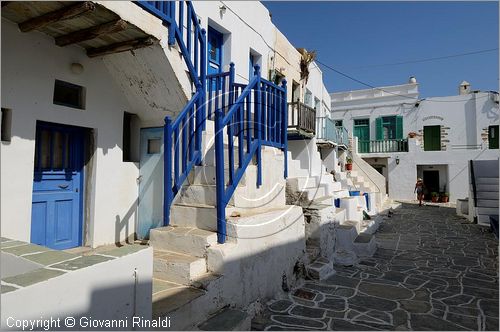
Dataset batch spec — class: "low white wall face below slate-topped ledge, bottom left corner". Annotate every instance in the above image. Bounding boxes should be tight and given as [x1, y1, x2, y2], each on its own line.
[1, 248, 153, 330]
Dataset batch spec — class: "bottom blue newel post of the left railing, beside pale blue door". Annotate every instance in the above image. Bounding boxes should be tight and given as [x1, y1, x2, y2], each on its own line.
[163, 116, 173, 226]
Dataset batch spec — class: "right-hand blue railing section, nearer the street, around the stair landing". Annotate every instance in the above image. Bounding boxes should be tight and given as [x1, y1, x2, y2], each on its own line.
[215, 65, 288, 243]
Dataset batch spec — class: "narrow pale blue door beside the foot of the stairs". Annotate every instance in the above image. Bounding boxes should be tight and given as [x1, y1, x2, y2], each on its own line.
[136, 128, 163, 239]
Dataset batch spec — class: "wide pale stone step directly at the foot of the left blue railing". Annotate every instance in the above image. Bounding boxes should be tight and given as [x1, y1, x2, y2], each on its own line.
[149, 226, 217, 257]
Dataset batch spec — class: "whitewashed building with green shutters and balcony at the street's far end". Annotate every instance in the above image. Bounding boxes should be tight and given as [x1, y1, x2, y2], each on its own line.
[331, 77, 500, 201]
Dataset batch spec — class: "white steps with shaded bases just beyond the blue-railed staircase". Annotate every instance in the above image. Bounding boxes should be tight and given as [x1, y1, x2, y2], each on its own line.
[286, 145, 381, 280]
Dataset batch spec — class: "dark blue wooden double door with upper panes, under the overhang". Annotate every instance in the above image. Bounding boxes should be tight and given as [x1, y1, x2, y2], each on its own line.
[31, 122, 84, 250]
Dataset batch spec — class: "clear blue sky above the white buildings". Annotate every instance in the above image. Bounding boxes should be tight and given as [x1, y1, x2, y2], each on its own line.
[264, 1, 499, 97]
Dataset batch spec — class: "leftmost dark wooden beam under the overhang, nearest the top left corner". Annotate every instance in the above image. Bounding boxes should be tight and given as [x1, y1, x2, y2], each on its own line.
[19, 1, 95, 32]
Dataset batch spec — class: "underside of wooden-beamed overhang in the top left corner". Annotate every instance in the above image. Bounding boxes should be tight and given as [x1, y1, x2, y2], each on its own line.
[2, 1, 157, 57]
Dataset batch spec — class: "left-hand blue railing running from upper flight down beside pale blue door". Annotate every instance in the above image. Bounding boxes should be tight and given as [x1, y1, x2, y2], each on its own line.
[136, 1, 207, 225]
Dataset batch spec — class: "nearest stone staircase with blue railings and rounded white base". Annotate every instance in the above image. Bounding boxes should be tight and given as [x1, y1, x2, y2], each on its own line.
[150, 121, 297, 330]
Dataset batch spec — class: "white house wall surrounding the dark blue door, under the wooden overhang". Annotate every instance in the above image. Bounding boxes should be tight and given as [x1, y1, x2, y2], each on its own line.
[1, 19, 138, 246]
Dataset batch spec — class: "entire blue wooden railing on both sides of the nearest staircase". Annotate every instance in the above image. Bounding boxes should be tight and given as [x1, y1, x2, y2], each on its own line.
[137, 1, 288, 243]
